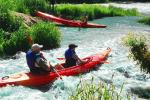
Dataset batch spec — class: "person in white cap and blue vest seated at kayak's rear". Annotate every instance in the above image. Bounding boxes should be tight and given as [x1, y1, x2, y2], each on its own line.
[26, 44, 51, 74]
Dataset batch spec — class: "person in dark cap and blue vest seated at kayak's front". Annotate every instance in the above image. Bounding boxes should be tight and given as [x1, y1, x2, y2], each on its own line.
[64, 44, 87, 68]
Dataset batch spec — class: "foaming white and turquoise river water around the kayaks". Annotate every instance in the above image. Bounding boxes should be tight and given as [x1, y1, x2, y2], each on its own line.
[0, 2, 150, 100]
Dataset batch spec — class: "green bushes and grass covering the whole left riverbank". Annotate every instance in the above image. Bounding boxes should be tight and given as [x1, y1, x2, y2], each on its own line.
[0, 0, 61, 57]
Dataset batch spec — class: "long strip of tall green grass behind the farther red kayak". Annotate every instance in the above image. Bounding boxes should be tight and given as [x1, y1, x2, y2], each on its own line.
[55, 4, 139, 20]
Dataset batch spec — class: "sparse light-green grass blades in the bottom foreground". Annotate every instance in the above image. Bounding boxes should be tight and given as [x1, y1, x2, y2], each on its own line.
[68, 80, 130, 100]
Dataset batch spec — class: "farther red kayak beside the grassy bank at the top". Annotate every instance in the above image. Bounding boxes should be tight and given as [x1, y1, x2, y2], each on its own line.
[36, 11, 106, 28]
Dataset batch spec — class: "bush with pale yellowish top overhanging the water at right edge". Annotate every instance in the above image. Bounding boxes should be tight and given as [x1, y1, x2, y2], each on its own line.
[123, 33, 150, 73]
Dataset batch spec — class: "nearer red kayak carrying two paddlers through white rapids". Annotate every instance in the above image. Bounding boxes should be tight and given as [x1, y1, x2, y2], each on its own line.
[0, 48, 111, 87]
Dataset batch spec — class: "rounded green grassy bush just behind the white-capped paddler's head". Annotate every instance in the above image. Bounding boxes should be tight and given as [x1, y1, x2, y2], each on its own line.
[29, 22, 61, 49]
